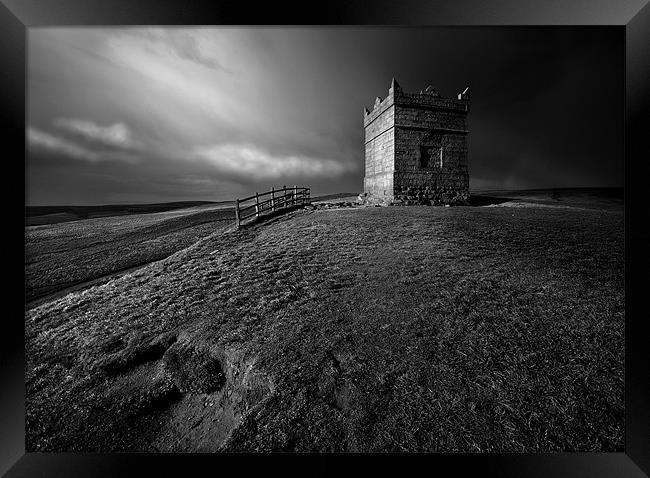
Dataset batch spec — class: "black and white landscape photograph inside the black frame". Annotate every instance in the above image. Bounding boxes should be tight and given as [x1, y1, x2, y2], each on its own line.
[3, 0, 640, 470]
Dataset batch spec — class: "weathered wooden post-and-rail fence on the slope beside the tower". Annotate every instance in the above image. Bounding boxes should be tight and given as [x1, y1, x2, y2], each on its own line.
[235, 186, 311, 227]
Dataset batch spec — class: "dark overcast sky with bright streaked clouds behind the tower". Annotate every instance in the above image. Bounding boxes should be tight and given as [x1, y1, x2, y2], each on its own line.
[27, 27, 624, 205]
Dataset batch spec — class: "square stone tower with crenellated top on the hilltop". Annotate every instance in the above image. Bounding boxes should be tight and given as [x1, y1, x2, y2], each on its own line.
[363, 78, 469, 205]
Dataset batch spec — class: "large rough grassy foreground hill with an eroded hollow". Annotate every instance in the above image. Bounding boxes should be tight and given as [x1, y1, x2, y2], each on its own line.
[25, 200, 624, 452]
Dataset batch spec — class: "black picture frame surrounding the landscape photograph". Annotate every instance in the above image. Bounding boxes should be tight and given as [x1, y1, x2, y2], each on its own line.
[0, 0, 650, 477]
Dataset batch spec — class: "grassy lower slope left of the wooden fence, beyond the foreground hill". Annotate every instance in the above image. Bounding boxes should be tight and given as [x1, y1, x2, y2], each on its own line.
[25, 204, 235, 302]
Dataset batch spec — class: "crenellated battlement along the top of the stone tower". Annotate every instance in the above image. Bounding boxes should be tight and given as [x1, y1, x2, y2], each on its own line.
[363, 78, 470, 126]
